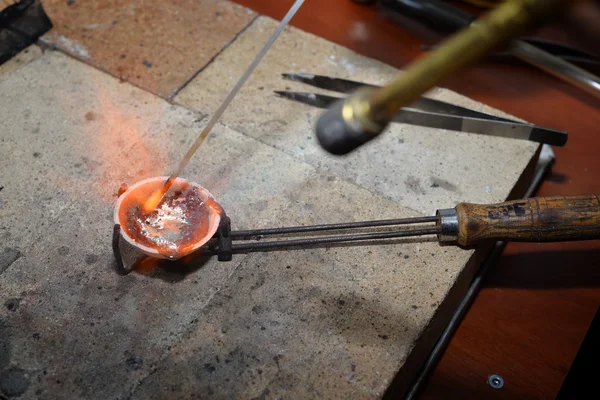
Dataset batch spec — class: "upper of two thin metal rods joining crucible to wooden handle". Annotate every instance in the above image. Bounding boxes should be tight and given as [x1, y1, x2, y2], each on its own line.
[231, 215, 437, 239]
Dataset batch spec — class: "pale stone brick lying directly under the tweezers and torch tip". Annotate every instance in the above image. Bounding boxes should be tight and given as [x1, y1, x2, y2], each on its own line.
[175, 17, 538, 213]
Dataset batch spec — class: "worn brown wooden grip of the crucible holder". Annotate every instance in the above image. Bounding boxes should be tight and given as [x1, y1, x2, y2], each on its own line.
[456, 194, 600, 246]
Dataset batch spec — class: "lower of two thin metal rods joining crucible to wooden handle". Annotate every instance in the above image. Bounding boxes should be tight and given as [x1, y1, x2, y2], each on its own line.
[232, 226, 440, 252]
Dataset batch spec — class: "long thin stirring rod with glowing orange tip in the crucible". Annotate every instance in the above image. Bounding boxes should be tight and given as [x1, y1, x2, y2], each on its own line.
[142, 0, 304, 213]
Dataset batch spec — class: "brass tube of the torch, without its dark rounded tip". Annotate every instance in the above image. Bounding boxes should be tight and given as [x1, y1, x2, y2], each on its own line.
[364, 0, 566, 126]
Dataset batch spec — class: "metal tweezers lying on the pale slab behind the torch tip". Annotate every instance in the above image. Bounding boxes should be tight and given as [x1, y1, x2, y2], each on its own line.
[275, 74, 568, 146]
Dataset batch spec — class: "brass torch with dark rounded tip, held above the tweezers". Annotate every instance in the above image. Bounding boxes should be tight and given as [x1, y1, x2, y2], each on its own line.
[315, 0, 566, 155]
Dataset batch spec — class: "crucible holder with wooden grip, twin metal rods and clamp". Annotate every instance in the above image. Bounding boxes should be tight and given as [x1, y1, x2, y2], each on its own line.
[201, 194, 600, 261]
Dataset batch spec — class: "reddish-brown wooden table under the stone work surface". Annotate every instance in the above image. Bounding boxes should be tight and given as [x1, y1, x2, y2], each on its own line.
[237, 0, 600, 398]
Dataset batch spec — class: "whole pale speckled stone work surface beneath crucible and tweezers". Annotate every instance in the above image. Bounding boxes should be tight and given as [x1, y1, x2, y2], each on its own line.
[0, 17, 537, 399]
